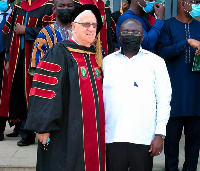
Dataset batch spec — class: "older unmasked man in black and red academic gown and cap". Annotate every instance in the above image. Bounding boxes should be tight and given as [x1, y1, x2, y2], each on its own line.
[25, 4, 105, 171]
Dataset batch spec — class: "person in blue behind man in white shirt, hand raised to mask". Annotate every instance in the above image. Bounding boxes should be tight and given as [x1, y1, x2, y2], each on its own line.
[116, 0, 164, 53]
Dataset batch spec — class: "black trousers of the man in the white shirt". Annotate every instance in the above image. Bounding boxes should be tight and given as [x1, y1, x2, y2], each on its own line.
[106, 142, 153, 171]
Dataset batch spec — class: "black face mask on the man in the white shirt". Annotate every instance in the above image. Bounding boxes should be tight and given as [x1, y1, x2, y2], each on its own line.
[121, 35, 142, 52]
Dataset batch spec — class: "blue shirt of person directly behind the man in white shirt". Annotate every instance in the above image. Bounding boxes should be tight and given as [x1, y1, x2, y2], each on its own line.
[116, 10, 164, 53]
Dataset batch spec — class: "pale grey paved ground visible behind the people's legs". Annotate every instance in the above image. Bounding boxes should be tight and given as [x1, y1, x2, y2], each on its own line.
[0, 123, 200, 171]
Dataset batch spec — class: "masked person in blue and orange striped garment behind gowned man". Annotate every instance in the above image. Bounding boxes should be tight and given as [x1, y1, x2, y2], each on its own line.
[29, 0, 74, 72]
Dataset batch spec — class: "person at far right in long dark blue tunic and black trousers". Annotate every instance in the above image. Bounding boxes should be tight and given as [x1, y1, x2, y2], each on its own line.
[158, 0, 200, 171]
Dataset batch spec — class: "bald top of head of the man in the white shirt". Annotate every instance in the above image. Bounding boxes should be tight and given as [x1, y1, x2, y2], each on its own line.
[120, 19, 143, 34]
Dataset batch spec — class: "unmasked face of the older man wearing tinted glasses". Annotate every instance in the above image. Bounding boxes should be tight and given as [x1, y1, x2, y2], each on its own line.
[72, 12, 97, 47]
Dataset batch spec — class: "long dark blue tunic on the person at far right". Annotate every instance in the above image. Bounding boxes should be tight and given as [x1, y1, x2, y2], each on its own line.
[158, 17, 200, 117]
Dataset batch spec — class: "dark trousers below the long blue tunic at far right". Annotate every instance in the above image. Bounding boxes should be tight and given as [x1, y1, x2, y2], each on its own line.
[164, 116, 200, 171]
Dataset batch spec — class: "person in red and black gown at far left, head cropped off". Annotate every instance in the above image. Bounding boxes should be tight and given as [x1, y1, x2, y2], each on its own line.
[0, 0, 54, 146]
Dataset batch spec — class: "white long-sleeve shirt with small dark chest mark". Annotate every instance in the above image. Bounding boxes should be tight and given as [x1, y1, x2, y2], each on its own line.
[103, 48, 172, 145]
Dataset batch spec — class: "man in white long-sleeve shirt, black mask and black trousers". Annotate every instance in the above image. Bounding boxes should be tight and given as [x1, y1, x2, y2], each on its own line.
[103, 19, 172, 171]
